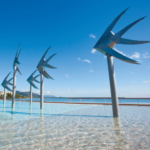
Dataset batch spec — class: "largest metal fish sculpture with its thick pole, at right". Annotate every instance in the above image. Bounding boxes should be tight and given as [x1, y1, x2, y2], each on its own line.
[94, 8, 150, 117]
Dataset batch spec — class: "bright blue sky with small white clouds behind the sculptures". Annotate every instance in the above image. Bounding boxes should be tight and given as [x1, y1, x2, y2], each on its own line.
[0, 0, 150, 97]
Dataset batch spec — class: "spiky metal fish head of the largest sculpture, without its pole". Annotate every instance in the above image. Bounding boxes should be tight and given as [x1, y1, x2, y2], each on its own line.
[94, 8, 150, 64]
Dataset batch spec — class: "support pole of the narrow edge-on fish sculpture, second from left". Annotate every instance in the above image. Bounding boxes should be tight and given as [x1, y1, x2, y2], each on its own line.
[12, 66, 17, 108]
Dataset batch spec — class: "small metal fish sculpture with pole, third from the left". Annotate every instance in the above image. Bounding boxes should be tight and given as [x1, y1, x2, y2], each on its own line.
[27, 70, 40, 106]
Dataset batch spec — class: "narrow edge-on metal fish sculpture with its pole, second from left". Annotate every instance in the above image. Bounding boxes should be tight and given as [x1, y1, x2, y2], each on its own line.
[12, 44, 21, 108]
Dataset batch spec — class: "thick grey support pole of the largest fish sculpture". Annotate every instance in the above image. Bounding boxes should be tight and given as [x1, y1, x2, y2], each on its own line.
[107, 54, 119, 117]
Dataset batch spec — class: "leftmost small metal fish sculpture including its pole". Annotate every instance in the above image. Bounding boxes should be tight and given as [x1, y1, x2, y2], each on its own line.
[1, 72, 13, 106]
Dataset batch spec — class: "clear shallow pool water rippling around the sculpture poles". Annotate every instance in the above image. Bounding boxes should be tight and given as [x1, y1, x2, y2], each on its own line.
[0, 101, 150, 150]
